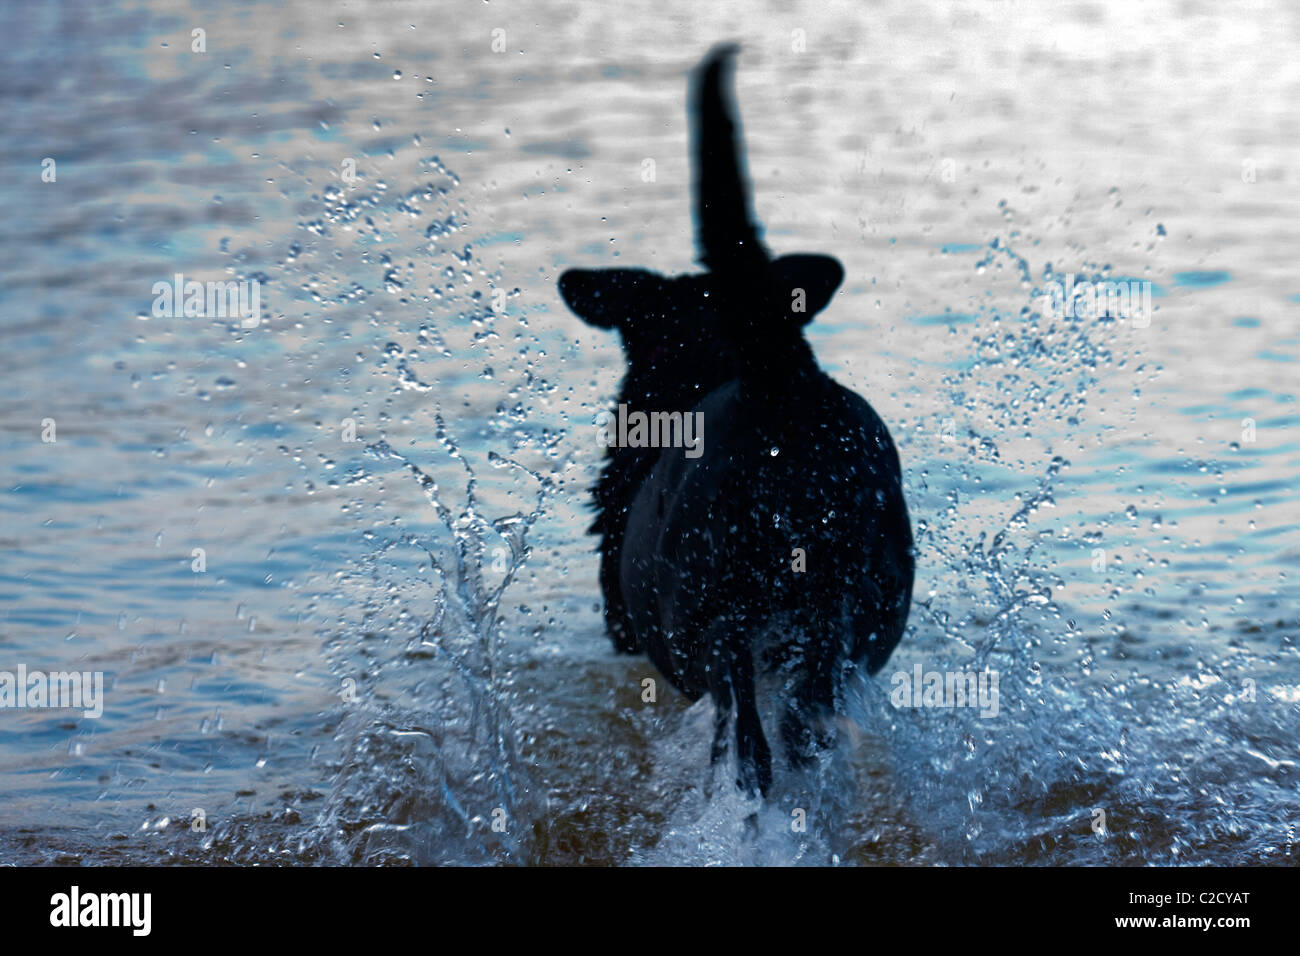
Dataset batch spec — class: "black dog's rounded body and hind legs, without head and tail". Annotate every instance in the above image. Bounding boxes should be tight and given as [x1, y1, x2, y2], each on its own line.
[620, 299, 913, 791]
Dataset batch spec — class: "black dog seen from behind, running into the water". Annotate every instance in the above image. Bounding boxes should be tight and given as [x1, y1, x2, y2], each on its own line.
[560, 44, 913, 795]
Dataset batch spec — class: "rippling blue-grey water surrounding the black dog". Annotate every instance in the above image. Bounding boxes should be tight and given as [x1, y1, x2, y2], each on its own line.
[0, 0, 1300, 864]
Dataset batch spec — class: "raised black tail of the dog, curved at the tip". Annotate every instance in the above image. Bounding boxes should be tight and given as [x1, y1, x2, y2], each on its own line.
[689, 43, 770, 274]
